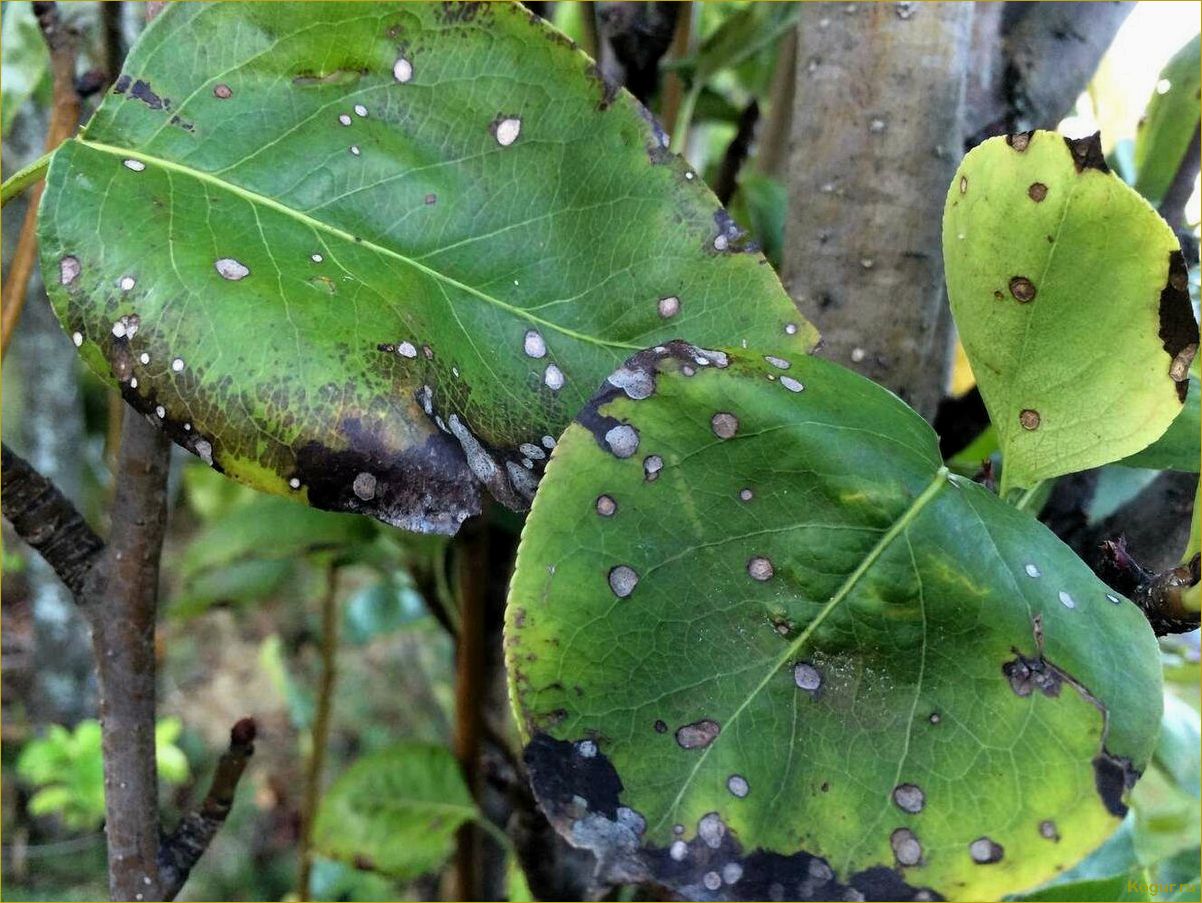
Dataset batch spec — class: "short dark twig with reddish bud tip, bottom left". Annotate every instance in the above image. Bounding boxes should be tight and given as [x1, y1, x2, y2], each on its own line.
[159, 718, 256, 899]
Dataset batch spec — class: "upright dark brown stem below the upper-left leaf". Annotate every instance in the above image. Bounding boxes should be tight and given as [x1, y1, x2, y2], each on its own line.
[92, 408, 169, 901]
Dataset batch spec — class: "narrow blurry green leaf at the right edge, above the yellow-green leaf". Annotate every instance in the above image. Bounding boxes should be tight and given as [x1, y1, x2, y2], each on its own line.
[1135, 35, 1202, 204]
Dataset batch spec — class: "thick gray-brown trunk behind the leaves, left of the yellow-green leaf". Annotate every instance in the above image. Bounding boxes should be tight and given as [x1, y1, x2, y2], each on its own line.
[784, 2, 972, 418]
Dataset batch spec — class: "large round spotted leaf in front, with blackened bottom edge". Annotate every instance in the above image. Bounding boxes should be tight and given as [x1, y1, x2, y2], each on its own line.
[506, 343, 1161, 899]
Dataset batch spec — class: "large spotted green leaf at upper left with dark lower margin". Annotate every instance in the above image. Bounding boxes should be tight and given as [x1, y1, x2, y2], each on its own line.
[40, 2, 816, 533]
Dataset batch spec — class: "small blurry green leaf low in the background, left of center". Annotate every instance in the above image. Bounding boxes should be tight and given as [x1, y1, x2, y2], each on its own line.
[314, 743, 477, 878]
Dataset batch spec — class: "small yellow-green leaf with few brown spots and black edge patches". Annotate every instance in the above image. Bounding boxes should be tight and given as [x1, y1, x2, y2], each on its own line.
[944, 131, 1198, 488]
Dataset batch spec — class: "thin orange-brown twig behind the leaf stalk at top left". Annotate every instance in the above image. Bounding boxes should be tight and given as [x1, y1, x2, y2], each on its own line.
[0, 2, 79, 354]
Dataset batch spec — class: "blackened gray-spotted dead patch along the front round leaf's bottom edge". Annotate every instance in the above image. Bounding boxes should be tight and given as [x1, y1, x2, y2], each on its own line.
[524, 733, 942, 901]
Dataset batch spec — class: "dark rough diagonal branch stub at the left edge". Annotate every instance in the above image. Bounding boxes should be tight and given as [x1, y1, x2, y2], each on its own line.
[0, 445, 105, 600]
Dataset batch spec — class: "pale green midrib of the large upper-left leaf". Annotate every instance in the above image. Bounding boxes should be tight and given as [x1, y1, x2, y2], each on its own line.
[73, 138, 642, 351]
